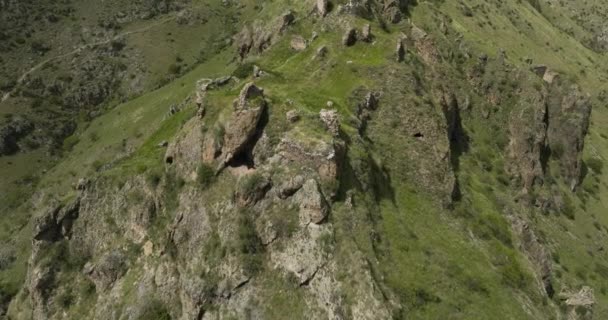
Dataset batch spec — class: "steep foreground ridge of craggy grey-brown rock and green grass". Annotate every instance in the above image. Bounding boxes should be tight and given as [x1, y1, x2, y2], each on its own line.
[0, 0, 608, 320]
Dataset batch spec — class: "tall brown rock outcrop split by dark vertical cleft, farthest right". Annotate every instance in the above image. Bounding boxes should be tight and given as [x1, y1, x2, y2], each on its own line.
[506, 76, 591, 194]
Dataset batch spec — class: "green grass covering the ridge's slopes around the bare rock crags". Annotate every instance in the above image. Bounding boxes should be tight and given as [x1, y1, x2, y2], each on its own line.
[0, 0, 608, 319]
